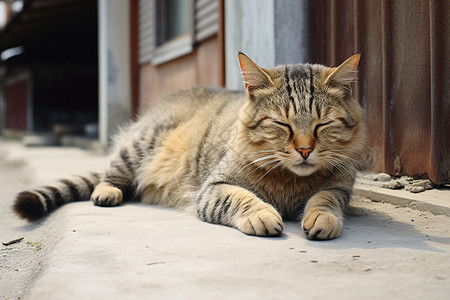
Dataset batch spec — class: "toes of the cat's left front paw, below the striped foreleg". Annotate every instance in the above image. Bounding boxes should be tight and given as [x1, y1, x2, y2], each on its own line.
[239, 206, 284, 236]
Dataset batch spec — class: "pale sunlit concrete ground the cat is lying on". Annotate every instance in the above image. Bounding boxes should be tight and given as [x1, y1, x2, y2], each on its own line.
[0, 140, 450, 299]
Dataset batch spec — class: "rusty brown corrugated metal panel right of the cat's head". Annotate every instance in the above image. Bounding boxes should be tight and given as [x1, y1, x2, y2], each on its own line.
[310, 0, 450, 184]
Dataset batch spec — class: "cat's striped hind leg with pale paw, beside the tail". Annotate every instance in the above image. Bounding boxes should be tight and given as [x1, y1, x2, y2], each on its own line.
[91, 148, 134, 206]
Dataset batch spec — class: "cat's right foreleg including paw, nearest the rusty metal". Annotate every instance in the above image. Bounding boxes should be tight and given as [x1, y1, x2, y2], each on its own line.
[302, 188, 350, 240]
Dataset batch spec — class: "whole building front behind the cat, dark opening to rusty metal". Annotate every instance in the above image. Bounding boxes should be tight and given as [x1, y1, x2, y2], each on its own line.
[0, 0, 450, 184]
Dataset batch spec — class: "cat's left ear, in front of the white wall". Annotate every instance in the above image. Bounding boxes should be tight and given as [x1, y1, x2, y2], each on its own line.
[238, 52, 273, 92]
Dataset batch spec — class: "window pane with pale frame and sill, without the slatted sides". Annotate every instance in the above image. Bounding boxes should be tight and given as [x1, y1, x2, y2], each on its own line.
[152, 0, 193, 65]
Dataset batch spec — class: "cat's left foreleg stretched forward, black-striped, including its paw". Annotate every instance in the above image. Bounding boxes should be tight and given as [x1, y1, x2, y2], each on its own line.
[196, 182, 283, 236]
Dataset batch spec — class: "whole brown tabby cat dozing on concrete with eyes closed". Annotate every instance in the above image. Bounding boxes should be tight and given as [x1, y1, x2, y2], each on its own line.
[13, 52, 365, 240]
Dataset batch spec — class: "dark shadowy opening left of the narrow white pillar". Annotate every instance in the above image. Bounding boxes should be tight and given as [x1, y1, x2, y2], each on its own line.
[0, 0, 98, 135]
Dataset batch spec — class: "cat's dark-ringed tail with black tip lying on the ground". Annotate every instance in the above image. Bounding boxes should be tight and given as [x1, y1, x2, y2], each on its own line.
[13, 173, 101, 222]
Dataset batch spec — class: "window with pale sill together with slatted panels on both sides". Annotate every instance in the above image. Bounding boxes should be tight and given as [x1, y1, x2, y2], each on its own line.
[139, 0, 219, 65]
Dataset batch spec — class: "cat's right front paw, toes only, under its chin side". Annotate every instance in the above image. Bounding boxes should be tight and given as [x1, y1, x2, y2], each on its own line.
[302, 209, 343, 240]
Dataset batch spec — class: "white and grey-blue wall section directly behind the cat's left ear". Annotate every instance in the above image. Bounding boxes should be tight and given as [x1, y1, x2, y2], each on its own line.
[225, 0, 310, 89]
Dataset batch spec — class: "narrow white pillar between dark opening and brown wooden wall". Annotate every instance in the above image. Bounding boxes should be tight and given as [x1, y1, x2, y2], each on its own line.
[98, 0, 131, 145]
